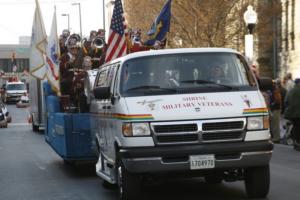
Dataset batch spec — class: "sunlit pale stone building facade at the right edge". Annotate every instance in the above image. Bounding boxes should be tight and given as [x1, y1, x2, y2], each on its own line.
[279, 0, 300, 78]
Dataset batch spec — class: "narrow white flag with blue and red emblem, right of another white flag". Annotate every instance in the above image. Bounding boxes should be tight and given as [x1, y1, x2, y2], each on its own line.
[46, 10, 60, 94]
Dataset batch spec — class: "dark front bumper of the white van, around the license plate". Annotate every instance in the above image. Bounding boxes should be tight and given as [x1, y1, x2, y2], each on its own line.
[119, 141, 273, 173]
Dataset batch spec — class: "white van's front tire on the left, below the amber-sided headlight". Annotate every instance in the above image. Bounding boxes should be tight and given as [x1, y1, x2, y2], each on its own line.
[117, 163, 141, 200]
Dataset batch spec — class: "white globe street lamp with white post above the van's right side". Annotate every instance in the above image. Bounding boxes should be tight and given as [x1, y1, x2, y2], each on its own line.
[244, 5, 257, 64]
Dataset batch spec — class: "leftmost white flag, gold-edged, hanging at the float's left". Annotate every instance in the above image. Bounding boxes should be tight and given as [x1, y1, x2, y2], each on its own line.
[30, 0, 47, 79]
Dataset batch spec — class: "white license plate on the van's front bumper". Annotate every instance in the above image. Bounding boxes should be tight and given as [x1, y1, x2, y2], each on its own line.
[190, 155, 215, 169]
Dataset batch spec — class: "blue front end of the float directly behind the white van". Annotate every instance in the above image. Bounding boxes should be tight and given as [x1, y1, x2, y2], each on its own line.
[45, 113, 97, 160]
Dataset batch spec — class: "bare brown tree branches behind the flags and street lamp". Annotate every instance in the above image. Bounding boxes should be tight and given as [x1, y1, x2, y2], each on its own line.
[125, 0, 280, 55]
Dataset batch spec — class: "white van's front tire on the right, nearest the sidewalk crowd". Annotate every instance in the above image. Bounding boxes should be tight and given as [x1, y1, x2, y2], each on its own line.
[244, 165, 270, 198]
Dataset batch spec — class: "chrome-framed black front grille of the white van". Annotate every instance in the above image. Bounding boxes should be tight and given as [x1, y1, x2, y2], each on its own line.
[151, 118, 246, 145]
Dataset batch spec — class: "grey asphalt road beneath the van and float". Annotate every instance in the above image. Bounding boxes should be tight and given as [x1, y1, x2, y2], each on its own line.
[0, 105, 300, 200]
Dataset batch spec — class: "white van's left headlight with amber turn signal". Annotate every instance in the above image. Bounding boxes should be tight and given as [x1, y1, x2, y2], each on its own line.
[122, 123, 151, 137]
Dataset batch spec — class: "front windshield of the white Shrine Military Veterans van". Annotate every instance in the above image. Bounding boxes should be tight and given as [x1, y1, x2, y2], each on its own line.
[120, 52, 256, 96]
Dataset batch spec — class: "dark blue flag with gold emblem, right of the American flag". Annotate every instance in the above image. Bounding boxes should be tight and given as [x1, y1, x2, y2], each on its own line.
[145, 0, 172, 46]
